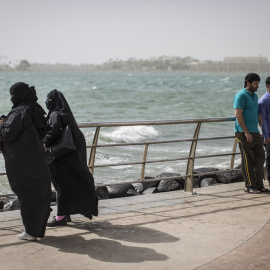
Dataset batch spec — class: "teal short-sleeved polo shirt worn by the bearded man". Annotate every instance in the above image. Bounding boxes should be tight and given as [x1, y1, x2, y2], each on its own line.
[233, 88, 260, 133]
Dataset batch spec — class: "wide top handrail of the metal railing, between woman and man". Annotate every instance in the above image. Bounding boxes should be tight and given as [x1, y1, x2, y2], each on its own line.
[78, 117, 235, 128]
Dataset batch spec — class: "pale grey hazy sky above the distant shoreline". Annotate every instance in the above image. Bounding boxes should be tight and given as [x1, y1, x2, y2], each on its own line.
[0, 0, 270, 64]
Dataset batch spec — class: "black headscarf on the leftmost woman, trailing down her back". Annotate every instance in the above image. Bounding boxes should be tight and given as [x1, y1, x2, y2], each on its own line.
[9, 82, 47, 136]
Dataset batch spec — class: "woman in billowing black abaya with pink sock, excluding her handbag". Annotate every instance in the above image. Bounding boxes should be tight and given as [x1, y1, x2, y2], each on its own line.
[43, 90, 98, 227]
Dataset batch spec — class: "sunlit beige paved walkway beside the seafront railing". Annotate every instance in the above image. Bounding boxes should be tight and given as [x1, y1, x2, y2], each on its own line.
[0, 183, 270, 270]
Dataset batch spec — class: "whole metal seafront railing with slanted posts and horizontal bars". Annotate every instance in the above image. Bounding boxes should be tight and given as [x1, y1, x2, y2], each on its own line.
[0, 117, 239, 193]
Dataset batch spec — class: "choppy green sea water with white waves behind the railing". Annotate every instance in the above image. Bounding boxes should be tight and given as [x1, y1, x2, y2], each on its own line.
[0, 72, 268, 194]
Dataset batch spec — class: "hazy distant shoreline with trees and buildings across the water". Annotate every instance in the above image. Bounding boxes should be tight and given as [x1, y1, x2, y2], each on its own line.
[0, 56, 270, 73]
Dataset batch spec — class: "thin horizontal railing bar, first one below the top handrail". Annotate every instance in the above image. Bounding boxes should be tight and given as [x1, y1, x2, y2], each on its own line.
[87, 136, 235, 148]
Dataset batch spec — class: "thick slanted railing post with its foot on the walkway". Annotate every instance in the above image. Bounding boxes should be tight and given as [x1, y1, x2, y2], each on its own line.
[185, 122, 201, 193]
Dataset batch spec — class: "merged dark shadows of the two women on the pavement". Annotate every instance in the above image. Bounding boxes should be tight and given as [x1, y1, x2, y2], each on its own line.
[38, 222, 177, 263]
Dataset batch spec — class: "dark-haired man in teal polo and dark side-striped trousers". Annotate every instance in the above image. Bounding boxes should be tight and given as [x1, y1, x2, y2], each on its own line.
[234, 73, 269, 194]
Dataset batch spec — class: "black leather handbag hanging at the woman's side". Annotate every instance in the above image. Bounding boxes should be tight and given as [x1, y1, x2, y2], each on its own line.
[45, 125, 76, 163]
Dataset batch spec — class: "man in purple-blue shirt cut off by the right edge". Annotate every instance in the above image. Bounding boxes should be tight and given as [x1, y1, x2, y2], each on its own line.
[259, 77, 270, 185]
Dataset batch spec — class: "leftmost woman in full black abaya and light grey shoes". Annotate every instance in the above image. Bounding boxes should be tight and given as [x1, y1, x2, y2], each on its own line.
[0, 82, 52, 241]
